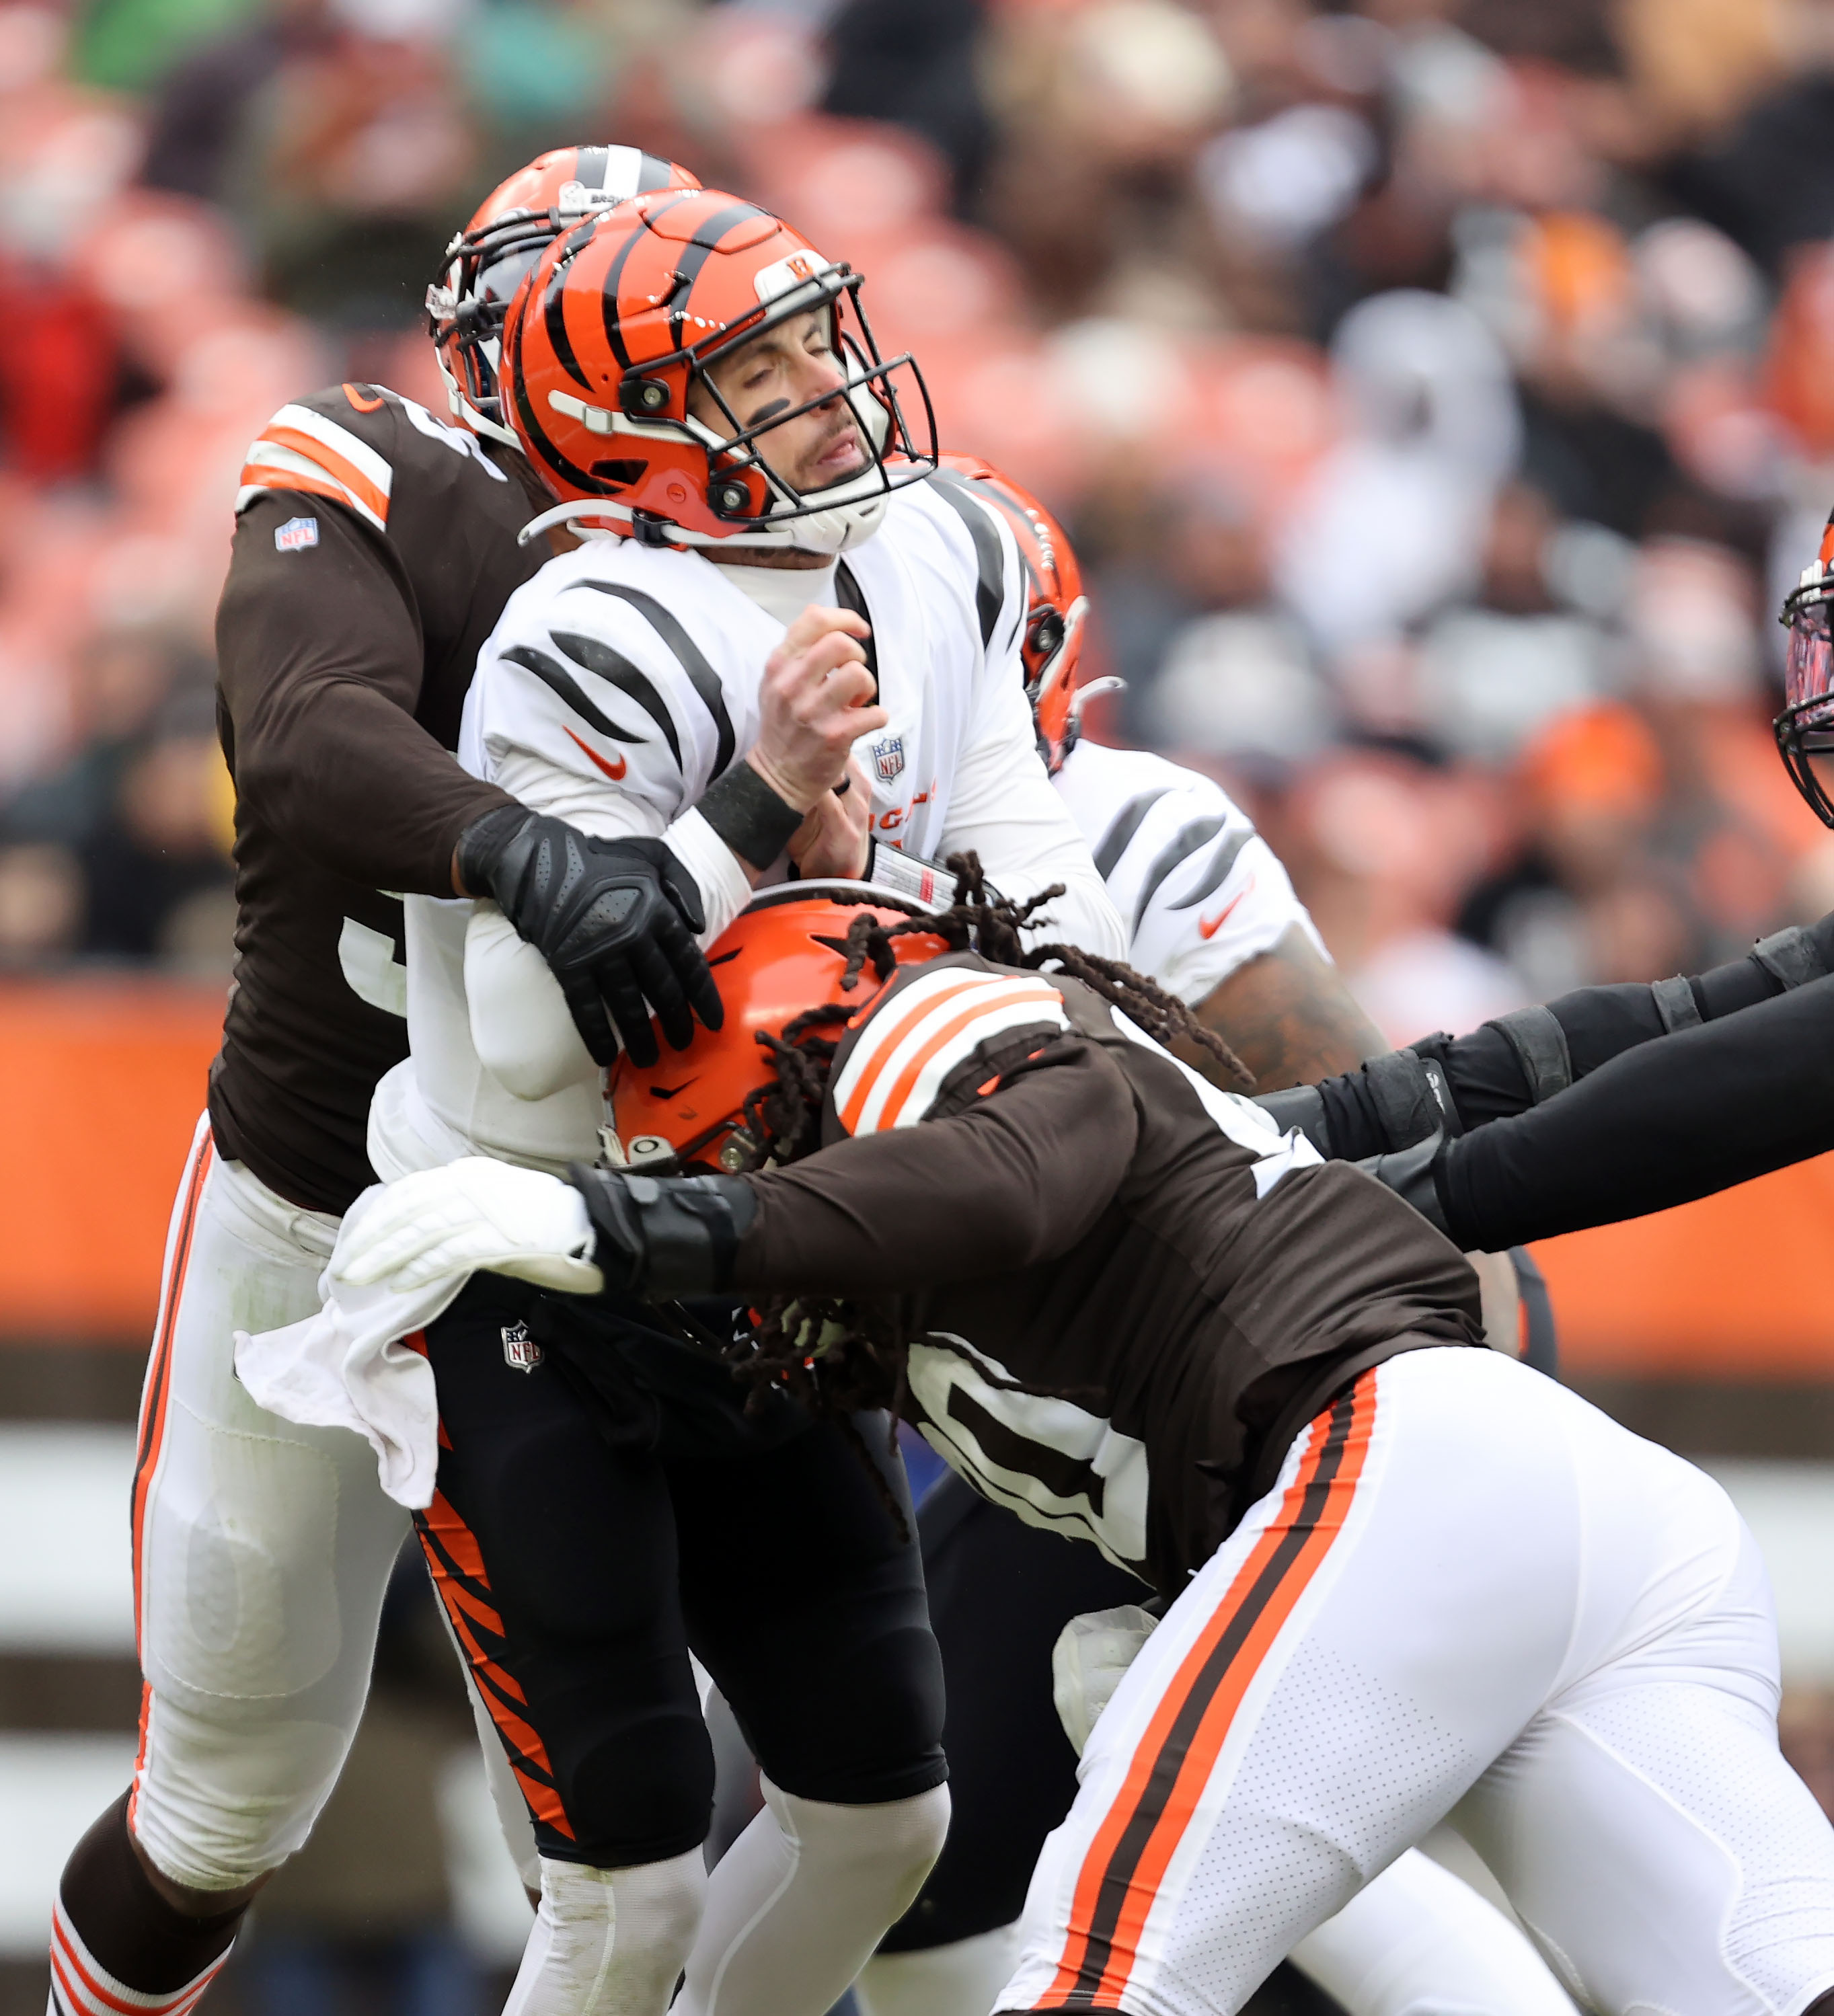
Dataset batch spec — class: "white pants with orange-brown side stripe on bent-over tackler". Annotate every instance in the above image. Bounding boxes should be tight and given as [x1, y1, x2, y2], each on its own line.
[997, 1349, 1834, 2016]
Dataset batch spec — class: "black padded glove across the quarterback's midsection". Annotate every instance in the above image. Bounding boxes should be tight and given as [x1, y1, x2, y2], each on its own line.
[457, 804, 726, 1067]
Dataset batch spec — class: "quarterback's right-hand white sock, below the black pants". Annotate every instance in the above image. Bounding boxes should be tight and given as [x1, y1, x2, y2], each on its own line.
[675, 1778, 949, 2016]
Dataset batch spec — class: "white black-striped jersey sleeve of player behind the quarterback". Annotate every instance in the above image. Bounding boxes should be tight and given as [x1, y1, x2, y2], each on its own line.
[1056, 742, 1330, 1008]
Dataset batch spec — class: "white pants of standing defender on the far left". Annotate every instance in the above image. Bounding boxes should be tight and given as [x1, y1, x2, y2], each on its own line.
[133, 1121, 407, 1889]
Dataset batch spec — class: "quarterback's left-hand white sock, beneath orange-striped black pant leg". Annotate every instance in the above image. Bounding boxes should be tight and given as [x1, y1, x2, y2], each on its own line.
[504, 1849, 708, 2016]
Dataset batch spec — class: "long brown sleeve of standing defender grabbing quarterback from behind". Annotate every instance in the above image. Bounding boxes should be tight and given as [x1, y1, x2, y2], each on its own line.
[216, 492, 514, 895]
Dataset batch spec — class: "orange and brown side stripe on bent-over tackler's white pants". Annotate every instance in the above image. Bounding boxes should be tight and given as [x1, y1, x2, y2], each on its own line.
[1034, 1375, 1375, 2010]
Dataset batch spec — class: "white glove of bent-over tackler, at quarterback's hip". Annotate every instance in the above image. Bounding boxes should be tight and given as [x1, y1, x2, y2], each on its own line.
[330, 1155, 605, 1294]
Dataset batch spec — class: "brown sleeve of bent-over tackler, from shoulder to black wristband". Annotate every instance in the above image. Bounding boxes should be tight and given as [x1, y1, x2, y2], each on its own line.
[734, 1038, 1139, 1294]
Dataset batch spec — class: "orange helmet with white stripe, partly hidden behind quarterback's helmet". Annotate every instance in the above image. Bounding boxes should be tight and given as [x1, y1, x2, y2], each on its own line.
[427, 147, 701, 448]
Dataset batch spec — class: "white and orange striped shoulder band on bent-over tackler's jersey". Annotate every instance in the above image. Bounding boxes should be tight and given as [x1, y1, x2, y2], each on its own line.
[835, 966, 1070, 1135]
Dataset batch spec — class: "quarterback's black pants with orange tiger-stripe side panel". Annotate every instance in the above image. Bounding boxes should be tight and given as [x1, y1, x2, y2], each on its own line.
[417, 1274, 947, 1869]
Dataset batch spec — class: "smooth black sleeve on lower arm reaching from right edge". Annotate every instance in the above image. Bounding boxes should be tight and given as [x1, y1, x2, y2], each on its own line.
[1435, 978, 1834, 1252]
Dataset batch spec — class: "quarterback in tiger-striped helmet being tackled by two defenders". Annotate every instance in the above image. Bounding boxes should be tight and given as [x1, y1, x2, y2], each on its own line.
[320, 192, 1124, 2016]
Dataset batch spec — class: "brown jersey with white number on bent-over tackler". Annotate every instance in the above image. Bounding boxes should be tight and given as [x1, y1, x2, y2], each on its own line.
[734, 954, 1482, 1590]
